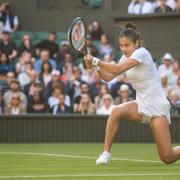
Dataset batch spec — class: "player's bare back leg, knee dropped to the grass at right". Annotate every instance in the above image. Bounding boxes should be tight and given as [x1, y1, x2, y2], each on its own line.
[150, 117, 180, 164]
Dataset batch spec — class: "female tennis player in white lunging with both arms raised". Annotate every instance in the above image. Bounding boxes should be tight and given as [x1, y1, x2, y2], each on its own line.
[84, 24, 180, 165]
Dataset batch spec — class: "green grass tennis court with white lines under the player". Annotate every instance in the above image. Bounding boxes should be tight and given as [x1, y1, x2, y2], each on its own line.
[0, 144, 180, 180]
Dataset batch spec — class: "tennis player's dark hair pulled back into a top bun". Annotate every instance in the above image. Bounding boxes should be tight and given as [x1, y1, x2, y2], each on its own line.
[119, 23, 144, 47]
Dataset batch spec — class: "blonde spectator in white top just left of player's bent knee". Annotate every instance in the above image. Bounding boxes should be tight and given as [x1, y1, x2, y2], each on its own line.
[96, 94, 115, 115]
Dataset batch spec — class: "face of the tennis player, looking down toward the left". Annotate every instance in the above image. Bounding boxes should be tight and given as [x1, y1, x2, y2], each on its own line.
[119, 37, 137, 57]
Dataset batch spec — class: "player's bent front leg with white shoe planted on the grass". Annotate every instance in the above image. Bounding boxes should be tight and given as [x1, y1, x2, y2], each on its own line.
[96, 101, 143, 165]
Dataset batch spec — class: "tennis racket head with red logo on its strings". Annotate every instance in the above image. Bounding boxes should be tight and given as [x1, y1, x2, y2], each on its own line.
[68, 17, 87, 51]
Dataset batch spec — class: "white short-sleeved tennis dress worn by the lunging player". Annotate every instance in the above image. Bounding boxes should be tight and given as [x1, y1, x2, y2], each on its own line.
[119, 47, 171, 123]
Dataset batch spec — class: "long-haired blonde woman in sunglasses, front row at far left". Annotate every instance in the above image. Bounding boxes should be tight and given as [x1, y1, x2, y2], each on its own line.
[4, 93, 26, 115]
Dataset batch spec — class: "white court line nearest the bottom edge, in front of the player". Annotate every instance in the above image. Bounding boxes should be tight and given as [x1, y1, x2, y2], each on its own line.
[0, 173, 180, 179]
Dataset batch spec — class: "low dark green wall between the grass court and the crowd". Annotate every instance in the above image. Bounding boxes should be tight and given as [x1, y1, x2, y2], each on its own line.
[0, 115, 180, 143]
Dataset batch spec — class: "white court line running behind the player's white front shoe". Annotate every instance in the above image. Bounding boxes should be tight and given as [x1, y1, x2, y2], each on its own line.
[0, 152, 162, 164]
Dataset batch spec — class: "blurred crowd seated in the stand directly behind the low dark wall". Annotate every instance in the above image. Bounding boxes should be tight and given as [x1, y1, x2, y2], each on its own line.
[0, 1, 180, 115]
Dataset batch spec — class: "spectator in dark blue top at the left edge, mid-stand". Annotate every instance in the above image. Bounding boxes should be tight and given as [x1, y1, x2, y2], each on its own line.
[0, 53, 14, 75]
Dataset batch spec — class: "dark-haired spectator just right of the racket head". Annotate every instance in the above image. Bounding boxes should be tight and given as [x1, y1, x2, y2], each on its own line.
[89, 21, 104, 41]
